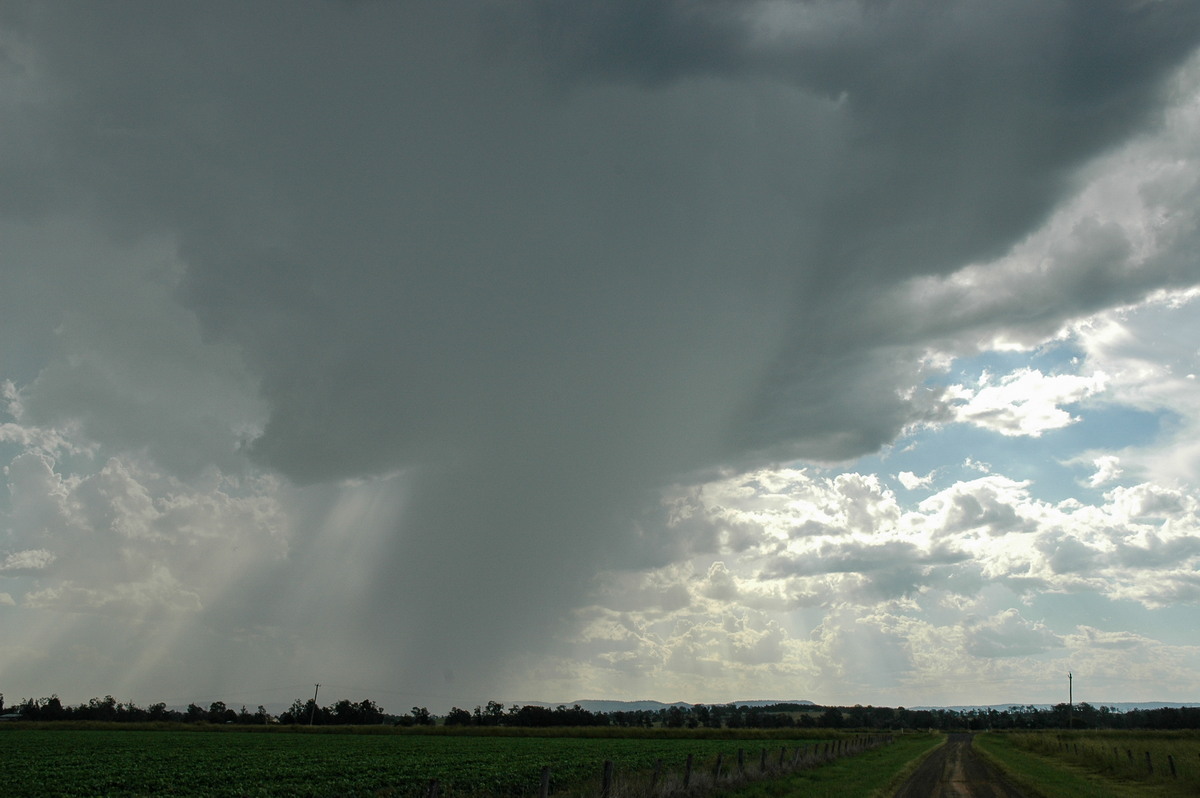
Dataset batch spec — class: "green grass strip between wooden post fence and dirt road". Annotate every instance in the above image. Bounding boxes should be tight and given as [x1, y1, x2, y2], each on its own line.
[708, 734, 946, 798]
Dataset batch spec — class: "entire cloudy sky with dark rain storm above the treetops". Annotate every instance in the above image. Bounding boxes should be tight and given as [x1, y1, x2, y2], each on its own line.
[0, 0, 1200, 713]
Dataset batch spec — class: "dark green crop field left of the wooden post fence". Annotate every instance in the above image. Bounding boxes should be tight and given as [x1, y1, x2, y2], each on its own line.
[0, 728, 844, 798]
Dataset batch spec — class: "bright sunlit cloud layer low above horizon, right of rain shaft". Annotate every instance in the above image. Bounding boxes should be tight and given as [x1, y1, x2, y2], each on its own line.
[549, 460, 1200, 703]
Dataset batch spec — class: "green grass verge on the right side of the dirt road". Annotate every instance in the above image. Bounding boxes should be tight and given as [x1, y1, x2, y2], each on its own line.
[974, 733, 1193, 798]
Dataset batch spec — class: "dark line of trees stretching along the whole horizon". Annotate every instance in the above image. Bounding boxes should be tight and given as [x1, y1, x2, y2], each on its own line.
[0, 694, 1200, 731]
